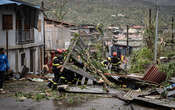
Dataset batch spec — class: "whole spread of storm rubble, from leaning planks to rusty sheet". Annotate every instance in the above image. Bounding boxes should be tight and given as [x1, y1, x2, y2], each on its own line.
[8, 35, 175, 109]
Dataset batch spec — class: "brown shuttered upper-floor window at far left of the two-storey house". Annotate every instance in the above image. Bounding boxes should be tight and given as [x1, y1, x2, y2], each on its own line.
[2, 15, 13, 30]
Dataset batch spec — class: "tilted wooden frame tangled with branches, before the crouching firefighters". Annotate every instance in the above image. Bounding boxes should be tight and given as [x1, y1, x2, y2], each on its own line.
[58, 35, 113, 86]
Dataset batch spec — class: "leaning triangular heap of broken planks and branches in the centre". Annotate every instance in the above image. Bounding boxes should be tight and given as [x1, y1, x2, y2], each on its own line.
[61, 34, 112, 86]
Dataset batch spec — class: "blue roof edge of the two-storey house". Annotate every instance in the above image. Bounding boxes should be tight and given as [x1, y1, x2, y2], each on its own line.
[0, 0, 40, 9]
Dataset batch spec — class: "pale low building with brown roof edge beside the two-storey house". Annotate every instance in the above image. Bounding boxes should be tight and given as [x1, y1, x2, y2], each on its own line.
[44, 18, 74, 50]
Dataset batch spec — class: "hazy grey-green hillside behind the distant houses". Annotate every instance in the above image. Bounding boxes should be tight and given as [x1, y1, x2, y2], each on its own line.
[25, 0, 175, 25]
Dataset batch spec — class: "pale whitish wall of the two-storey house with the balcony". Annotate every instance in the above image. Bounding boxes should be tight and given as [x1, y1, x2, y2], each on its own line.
[0, 7, 44, 73]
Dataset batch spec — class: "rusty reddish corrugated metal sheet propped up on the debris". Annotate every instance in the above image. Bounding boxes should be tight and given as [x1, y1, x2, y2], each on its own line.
[142, 65, 166, 84]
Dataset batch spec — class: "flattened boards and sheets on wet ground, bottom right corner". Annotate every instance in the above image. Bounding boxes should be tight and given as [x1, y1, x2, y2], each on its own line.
[113, 90, 175, 110]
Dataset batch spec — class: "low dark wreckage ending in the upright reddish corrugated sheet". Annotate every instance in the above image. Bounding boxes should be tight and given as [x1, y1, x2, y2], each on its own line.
[108, 65, 167, 89]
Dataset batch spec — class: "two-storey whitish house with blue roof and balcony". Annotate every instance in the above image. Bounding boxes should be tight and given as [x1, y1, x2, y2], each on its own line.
[0, 0, 44, 73]
